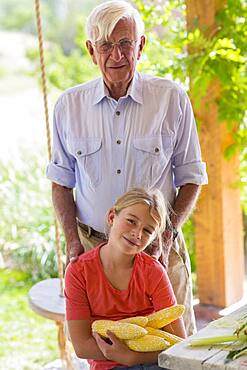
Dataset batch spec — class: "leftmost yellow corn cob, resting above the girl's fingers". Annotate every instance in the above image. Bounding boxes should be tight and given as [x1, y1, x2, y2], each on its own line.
[92, 320, 147, 339]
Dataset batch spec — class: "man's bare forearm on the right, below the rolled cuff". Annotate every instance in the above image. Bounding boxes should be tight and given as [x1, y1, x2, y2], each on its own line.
[170, 184, 201, 229]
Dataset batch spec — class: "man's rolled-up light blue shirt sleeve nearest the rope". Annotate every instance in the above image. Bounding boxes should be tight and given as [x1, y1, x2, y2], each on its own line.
[46, 101, 75, 188]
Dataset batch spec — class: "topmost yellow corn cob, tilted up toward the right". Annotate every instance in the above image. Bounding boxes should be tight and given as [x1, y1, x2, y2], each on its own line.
[147, 304, 185, 329]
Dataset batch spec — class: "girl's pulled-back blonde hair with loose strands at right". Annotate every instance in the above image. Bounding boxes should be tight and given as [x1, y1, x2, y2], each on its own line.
[110, 188, 169, 252]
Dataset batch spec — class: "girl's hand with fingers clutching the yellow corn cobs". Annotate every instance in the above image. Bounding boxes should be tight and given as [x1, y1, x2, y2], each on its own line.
[93, 330, 133, 366]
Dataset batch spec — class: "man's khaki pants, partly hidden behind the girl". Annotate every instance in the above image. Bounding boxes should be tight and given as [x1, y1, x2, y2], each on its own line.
[78, 225, 196, 335]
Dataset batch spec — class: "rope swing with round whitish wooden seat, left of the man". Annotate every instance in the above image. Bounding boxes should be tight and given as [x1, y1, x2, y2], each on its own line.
[28, 0, 75, 370]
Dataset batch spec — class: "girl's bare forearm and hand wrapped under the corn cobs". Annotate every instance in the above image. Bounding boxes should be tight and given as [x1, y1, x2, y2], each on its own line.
[93, 331, 160, 366]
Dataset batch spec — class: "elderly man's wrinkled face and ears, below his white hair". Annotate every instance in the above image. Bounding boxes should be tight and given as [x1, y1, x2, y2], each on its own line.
[87, 19, 145, 88]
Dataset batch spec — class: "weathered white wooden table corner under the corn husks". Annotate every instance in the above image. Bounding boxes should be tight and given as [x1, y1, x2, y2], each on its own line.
[159, 305, 247, 370]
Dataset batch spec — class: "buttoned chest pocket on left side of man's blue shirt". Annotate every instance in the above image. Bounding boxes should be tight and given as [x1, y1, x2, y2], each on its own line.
[71, 138, 102, 187]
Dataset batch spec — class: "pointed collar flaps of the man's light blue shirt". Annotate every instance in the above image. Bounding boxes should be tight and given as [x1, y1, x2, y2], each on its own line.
[93, 71, 143, 104]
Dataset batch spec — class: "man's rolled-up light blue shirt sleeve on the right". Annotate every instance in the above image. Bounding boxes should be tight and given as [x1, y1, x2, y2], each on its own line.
[172, 93, 208, 187]
